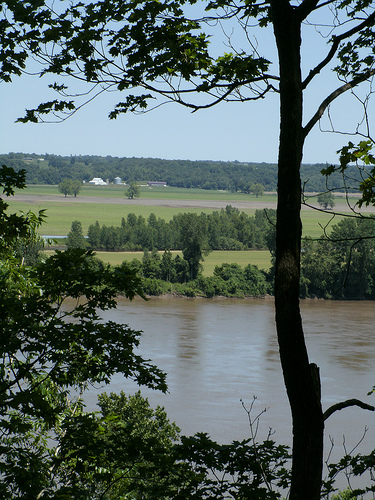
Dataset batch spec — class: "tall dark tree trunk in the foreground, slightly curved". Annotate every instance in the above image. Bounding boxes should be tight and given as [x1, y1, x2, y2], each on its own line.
[271, 0, 324, 500]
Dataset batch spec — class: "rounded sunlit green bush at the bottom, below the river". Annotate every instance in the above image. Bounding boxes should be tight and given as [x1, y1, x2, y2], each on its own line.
[55, 392, 188, 500]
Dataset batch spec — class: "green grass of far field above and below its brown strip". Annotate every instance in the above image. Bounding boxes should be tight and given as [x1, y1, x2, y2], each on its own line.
[7, 185, 360, 237]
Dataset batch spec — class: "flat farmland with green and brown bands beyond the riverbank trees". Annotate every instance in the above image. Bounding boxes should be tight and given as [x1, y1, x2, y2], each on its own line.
[7, 185, 368, 237]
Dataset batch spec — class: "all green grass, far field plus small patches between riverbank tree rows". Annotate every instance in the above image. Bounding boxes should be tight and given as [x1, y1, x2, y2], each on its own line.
[28, 185, 358, 275]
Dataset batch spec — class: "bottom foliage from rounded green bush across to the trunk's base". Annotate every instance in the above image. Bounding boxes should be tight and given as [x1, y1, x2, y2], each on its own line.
[44, 392, 290, 500]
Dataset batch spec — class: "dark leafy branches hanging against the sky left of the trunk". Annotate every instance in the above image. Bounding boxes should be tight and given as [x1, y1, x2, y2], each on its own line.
[2, 0, 277, 122]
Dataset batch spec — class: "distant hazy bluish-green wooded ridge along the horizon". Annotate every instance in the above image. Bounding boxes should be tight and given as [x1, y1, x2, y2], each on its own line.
[0, 153, 362, 193]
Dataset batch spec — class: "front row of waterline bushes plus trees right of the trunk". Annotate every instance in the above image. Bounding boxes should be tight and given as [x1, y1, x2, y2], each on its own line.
[131, 218, 375, 300]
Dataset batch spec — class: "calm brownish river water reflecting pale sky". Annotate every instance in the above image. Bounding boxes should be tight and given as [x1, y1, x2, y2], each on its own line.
[87, 298, 375, 472]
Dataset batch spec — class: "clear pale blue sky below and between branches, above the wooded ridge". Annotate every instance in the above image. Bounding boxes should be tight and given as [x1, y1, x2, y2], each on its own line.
[0, 9, 374, 163]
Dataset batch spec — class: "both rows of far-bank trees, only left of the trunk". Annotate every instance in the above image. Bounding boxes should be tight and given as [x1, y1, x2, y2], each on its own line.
[67, 206, 276, 297]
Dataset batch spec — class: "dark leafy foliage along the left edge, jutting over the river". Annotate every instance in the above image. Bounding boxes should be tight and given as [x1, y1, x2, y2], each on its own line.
[0, 168, 166, 499]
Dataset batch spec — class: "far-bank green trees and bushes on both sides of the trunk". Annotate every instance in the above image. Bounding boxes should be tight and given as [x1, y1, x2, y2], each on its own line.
[68, 206, 375, 299]
